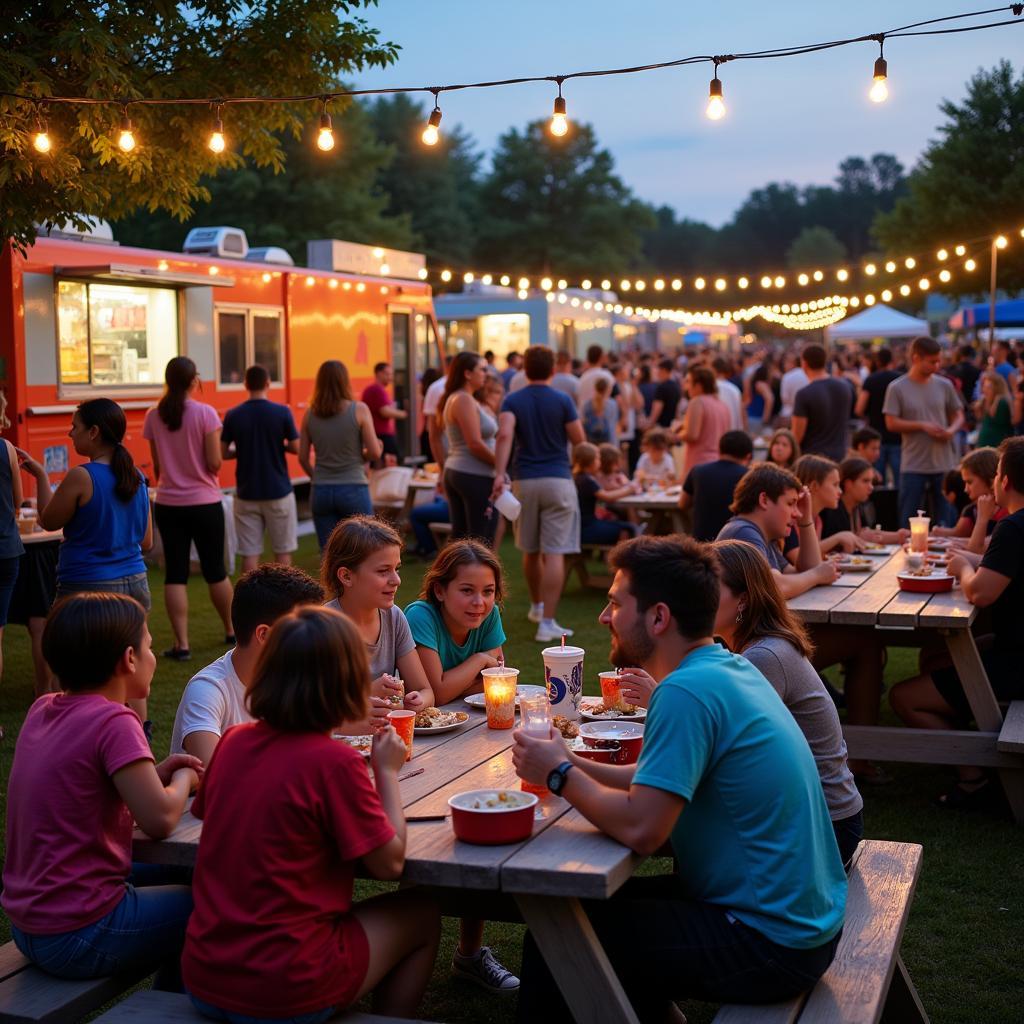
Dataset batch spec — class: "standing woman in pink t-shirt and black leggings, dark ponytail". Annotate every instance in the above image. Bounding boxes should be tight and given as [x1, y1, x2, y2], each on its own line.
[142, 355, 234, 662]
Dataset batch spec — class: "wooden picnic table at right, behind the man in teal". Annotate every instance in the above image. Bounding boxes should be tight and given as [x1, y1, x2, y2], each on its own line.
[787, 548, 1024, 824]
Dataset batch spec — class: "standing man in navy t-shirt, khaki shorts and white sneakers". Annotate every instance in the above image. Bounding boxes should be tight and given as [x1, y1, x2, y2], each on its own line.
[490, 345, 585, 643]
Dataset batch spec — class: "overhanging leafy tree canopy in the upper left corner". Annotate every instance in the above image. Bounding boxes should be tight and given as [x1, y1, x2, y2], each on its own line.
[0, 0, 397, 251]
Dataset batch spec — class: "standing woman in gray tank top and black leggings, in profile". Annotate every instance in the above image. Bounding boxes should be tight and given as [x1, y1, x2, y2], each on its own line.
[437, 352, 498, 547]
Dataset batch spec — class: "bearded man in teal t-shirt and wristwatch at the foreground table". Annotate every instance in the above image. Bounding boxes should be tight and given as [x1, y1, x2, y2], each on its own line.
[513, 537, 846, 1021]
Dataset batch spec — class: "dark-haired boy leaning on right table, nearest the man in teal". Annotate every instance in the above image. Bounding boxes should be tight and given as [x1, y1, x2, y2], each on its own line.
[716, 463, 839, 598]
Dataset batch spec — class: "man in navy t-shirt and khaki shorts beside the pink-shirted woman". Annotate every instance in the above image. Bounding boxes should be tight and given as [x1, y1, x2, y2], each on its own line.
[220, 365, 299, 572]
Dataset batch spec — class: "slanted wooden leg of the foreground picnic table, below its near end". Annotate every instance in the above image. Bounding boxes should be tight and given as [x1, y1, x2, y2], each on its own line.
[516, 896, 639, 1024]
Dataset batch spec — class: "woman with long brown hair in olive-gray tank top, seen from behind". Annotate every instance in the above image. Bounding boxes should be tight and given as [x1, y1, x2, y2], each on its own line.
[299, 359, 382, 551]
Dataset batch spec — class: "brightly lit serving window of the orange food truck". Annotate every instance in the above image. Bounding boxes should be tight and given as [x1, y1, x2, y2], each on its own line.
[57, 281, 178, 387]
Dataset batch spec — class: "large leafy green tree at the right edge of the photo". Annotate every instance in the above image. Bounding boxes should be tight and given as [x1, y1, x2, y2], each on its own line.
[874, 60, 1024, 294]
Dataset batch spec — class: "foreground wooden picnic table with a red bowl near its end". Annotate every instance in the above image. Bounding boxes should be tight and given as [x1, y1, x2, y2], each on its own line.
[133, 700, 643, 1024]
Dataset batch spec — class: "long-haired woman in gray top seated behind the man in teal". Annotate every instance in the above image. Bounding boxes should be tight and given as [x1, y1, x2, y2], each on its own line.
[713, 541, 864, 867]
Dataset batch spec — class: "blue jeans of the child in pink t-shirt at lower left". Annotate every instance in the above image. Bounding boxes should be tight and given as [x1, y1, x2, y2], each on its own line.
[11, 864, 193, 991]
